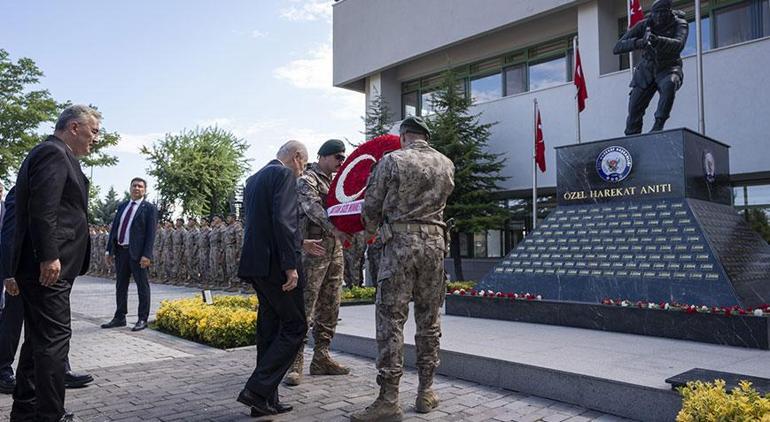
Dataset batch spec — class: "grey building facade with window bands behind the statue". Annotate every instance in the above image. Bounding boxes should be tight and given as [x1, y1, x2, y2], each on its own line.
[333, 0, 770, 278]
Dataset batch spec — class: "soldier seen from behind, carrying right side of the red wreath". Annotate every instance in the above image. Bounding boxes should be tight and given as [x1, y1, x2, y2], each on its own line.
[351, 117, 454, 421]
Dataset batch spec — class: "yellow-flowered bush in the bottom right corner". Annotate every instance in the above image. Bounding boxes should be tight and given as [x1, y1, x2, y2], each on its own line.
[676, 380, 770, 422]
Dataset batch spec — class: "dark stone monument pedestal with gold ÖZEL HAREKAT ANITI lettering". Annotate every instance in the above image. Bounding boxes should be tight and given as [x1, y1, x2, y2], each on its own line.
[479, 129, 770, 308]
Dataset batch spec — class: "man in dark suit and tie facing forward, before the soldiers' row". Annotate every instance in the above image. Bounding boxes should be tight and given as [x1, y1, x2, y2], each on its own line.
[102, 177, 158, 331]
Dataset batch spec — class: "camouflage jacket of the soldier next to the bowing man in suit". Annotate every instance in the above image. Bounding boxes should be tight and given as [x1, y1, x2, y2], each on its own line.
[297, 163, 334, 239]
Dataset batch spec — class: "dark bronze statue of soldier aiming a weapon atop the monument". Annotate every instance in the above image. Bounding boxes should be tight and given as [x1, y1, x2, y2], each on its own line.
[613, 0, 689, 135]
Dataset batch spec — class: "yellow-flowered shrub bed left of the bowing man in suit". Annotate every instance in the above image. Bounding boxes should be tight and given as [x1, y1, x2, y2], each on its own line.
[156, 295, 258, 348]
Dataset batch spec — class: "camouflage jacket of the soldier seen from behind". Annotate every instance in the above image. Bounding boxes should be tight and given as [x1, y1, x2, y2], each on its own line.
[363, 141, 454, 234]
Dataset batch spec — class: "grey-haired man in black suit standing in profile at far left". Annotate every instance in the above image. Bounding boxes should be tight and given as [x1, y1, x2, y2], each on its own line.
[9, 105, 101, 422]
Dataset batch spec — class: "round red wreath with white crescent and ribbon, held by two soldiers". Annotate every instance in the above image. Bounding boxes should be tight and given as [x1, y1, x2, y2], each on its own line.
[326, 135, 401, 233]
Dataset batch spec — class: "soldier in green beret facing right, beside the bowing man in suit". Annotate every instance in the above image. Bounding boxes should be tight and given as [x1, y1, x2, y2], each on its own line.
[285, 139, 350, 385]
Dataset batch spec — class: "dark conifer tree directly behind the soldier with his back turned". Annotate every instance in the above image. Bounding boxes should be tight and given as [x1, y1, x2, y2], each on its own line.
[427, 71, 508, 280]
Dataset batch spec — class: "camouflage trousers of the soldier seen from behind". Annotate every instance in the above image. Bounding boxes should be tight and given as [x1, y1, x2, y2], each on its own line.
[375, 233, 446, 383]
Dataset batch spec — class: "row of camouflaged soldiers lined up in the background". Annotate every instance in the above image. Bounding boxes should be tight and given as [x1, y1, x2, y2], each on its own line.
[89, 215, 376, 290]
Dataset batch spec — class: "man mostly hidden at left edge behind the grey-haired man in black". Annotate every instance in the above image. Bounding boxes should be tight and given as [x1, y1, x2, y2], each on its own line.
[0, 188, 94, 394]
